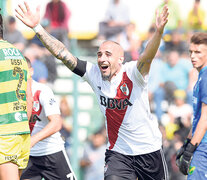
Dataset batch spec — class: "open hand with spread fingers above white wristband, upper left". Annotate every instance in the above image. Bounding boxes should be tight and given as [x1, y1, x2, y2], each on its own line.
[15, 1, 40, 28]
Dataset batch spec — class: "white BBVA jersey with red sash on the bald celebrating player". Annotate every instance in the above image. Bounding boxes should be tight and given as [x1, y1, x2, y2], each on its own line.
[83, 61, 162, 155]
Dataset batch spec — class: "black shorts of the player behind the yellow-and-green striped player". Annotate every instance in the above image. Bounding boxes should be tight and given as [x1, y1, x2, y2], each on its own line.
[21, 151, 75, 180]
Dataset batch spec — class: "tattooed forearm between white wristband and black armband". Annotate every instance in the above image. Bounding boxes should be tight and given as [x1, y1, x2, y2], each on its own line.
[36, 28, 77, 71]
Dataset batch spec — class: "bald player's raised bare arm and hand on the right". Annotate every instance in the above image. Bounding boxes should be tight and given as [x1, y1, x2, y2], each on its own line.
[137, 5, 169, 76]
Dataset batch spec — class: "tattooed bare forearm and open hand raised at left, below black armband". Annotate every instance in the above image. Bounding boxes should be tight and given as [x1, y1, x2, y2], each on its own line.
[15, 2, 77, 71]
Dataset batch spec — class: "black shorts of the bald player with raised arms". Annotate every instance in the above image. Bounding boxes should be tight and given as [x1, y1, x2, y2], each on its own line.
[104, 150, 169, 180]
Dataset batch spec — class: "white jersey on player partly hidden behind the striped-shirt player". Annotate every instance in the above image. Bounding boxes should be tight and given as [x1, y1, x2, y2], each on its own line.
[30, 81, 64, 156]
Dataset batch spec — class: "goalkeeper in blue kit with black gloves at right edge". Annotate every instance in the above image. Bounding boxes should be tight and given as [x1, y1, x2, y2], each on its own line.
[177, 32, 207, 180]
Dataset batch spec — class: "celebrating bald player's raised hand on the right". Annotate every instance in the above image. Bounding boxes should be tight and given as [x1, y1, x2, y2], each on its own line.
[156, 5, 169, 33]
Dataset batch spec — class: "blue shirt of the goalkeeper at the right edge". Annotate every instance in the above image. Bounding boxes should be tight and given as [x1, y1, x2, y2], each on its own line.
[192, 66, 207, 142]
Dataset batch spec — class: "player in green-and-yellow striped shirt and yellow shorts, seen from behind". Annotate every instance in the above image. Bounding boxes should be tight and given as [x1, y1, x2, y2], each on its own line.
[0, 8, 33, 180]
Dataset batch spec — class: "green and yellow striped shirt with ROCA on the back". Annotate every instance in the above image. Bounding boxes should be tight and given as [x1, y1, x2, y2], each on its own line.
[0, 40, 30, 135]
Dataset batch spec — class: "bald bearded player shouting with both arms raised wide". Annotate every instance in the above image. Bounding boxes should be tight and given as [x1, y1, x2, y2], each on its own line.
[16, 2, 169, 180]
